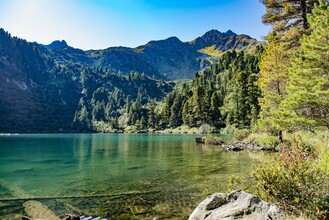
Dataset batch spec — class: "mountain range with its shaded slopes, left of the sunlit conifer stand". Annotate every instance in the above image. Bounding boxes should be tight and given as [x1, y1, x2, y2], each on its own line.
[0, 29, 259, 133]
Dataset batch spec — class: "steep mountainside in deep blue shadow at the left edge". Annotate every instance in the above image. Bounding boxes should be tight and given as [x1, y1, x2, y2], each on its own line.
[0, 29, 80, 132]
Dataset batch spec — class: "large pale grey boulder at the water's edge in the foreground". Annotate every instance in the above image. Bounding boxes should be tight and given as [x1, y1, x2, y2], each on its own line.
[189, 190, 285, 220]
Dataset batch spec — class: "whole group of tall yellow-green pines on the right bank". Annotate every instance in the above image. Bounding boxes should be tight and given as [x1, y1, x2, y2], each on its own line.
[258, 0, 329, 141]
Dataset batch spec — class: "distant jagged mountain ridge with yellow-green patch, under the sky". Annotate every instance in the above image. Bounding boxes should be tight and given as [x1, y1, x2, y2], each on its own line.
[40, 30, 260, 80]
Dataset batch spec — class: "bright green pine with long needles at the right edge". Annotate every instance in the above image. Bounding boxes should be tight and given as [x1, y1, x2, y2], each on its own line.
[282, 0, 329, 145]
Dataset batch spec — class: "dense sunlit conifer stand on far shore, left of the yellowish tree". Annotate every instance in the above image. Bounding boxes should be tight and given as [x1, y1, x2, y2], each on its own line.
[162, 47, 262, 131]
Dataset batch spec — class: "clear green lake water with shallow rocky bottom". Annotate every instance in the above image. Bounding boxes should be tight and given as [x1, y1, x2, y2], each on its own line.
[0, 134, 263, 219]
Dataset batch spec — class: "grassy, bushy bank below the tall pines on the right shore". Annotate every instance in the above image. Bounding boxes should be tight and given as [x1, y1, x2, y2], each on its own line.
[229, 129, 329, 219]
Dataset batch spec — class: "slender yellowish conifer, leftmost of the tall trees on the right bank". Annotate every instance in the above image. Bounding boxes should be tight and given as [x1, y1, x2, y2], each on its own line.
[257, 33, 291, 141]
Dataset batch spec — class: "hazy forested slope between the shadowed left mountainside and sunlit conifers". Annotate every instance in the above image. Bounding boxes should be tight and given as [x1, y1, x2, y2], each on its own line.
[73, 69, 173, 132]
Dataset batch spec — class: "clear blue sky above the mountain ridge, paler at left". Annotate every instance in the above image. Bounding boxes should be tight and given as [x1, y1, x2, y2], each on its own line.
[0, 0, 269, 49]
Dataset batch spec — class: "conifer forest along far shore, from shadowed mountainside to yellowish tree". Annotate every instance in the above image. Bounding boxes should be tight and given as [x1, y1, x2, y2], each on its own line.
[74, 47, 262, 132]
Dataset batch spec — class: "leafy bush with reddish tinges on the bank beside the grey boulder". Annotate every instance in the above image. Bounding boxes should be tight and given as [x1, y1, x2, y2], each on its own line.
[253, 137, 329, 216]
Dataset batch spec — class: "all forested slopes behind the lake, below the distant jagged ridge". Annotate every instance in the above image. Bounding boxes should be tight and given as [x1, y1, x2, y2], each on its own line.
[0, 26, 262, 132]
